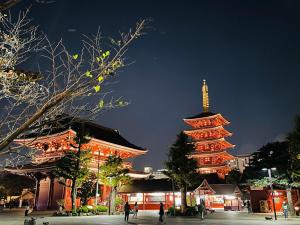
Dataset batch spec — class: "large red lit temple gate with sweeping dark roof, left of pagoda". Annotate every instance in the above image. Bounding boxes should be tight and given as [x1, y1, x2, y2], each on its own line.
[6, 116, 147, 210]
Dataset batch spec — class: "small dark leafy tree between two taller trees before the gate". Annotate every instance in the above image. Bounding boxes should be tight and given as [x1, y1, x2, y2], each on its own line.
[78, 173, 96, 205]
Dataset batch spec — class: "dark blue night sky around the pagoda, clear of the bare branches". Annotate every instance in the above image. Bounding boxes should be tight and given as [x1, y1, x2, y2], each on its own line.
[14, 0, 300, 169]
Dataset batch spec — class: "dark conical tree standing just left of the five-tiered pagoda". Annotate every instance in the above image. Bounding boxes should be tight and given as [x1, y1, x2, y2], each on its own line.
[165, 132, 199, 215]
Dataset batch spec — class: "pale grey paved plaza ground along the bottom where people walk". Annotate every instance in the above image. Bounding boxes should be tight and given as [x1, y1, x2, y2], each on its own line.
[0, 210, 300, 225]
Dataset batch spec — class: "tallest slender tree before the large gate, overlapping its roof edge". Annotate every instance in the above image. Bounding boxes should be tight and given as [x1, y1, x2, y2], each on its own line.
[55, 129, 92, 213]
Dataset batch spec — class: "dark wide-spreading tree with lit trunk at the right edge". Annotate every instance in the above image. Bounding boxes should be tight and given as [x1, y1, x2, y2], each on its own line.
[244, 139, 300, 213]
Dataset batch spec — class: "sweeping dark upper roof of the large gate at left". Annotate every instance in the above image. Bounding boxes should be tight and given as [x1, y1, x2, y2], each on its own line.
[16, 116, 147, 152]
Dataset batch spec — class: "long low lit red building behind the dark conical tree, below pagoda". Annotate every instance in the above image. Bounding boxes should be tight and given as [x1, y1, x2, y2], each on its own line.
[119, 171, 242, 211]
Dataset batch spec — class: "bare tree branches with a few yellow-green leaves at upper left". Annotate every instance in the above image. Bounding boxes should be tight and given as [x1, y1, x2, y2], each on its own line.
[0, 11, 147, 155]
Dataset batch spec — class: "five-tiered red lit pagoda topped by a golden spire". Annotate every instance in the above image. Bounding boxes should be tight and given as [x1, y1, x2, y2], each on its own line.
[184, 80, 235, 179]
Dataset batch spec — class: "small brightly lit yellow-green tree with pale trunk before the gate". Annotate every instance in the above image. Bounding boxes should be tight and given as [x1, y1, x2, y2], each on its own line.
[99, 155, 131, 213]
